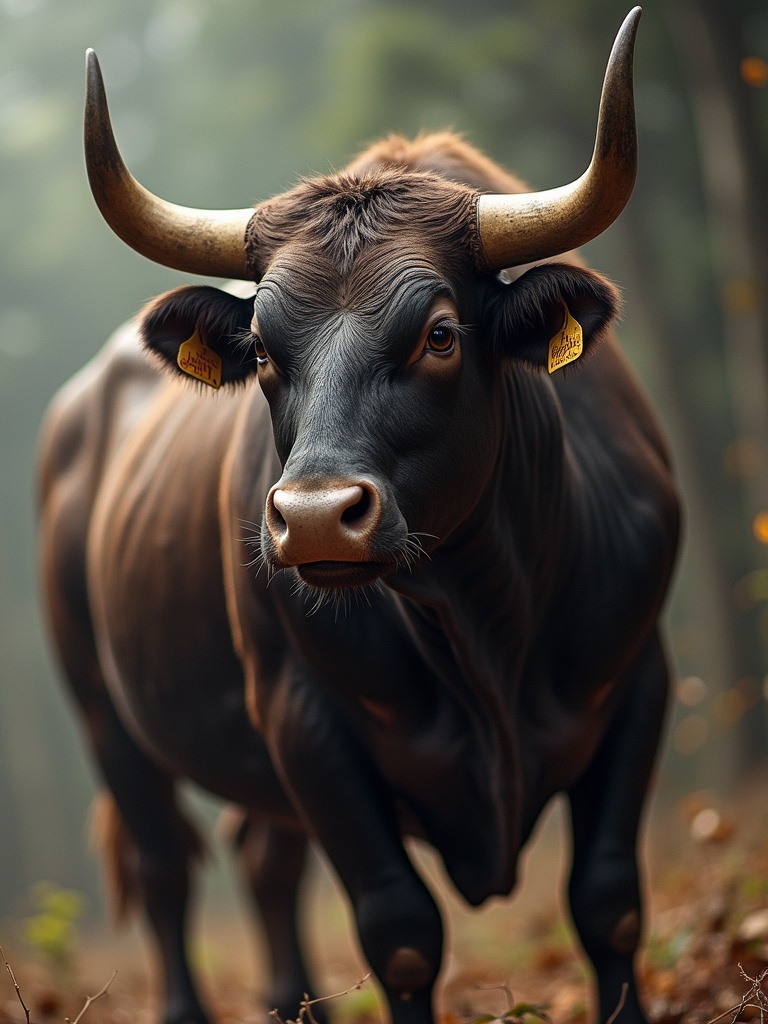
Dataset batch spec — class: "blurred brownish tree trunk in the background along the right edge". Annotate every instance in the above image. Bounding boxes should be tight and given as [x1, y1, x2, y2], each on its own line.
[665, 0, 768, 767]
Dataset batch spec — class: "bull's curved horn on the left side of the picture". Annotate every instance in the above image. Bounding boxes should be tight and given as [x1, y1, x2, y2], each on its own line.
[85, 50, 253, 280]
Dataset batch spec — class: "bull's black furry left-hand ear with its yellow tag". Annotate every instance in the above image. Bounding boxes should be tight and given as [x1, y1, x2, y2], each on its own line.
[139, 285, 257, 388]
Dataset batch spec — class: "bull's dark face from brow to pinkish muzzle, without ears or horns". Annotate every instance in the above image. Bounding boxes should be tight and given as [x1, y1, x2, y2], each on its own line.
[252, 246, 495, 588]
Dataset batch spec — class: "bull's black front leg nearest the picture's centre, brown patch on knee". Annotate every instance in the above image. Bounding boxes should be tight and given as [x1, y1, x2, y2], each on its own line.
[267, 674, 442, 1024]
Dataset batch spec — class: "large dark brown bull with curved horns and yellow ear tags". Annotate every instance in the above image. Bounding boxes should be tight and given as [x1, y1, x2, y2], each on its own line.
[40, 8, 679, 1024]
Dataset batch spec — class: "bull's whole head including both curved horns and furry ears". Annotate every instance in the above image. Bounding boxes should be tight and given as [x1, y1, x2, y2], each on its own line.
[85, 8, 640, 587]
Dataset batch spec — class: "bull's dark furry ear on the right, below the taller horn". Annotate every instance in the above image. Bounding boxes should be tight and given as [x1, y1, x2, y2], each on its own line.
[483, 263, 620, 368]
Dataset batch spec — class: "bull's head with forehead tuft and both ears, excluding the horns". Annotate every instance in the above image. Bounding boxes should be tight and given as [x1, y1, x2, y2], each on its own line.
[142, 176, 614, 590]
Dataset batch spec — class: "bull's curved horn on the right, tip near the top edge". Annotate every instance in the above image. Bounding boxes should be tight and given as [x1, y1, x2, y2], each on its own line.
[477, 7, 642, 270]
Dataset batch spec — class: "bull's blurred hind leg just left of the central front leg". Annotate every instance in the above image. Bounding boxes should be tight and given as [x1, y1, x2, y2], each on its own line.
[224, 814, 323, 1021]
